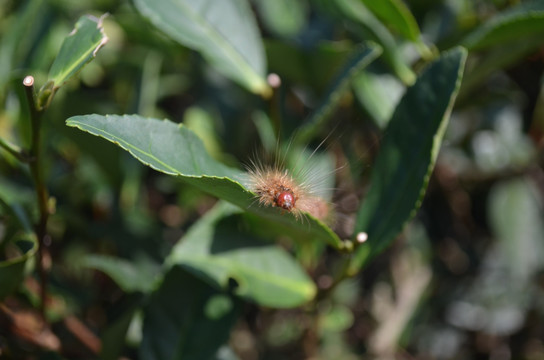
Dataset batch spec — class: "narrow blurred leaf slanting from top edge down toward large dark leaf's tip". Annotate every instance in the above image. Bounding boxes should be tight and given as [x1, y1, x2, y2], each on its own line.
[334, 0, 416, 85]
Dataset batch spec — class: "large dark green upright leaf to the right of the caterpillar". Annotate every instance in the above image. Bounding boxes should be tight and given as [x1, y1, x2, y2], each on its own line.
[350, 48, 467, 273]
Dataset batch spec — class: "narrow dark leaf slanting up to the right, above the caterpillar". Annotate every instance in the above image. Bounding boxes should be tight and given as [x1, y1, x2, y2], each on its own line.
[296, 43, 381, 143]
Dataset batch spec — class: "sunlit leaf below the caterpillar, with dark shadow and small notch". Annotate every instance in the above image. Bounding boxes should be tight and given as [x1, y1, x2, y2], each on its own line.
[166, 203, 316, 308]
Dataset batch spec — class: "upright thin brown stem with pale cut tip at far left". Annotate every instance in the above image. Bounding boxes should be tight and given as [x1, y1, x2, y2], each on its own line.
[23, 76, 49, 319]
